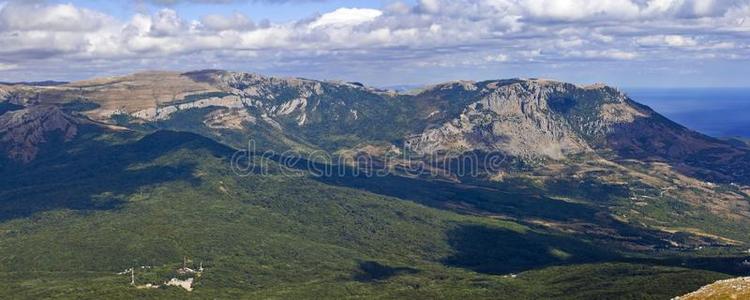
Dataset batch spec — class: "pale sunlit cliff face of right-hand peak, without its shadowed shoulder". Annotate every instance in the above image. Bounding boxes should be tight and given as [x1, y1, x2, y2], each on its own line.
[407, 81, 589, 159]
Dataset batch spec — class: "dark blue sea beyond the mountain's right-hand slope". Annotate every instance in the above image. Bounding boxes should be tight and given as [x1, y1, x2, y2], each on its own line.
[624, 88, 750, 138]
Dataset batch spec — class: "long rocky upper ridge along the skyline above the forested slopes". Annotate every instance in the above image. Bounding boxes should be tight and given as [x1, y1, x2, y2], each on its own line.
[0, 70, 750, 182]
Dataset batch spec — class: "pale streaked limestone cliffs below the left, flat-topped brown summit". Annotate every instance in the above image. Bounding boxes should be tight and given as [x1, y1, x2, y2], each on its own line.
[164, 70, 382, 129]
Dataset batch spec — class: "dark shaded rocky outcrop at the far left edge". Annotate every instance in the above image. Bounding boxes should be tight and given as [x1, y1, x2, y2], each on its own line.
[0, 106, 78, 162]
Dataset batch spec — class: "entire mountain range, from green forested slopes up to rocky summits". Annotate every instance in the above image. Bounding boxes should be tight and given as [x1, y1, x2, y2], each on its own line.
[0, 70, 750, 299]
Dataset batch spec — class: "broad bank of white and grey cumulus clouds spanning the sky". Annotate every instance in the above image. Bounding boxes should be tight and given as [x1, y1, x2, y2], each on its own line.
[0, 0, 750, 85]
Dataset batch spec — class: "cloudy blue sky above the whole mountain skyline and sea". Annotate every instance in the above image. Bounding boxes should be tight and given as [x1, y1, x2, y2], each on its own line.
[0, 0, 750, 87]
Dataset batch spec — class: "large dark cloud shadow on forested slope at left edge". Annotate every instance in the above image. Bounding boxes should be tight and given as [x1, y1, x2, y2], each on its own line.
[0, 128, 231, 221]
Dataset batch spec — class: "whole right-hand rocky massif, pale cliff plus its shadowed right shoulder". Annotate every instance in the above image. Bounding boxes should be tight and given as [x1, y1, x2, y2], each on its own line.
[407, 79, 651, 160]
